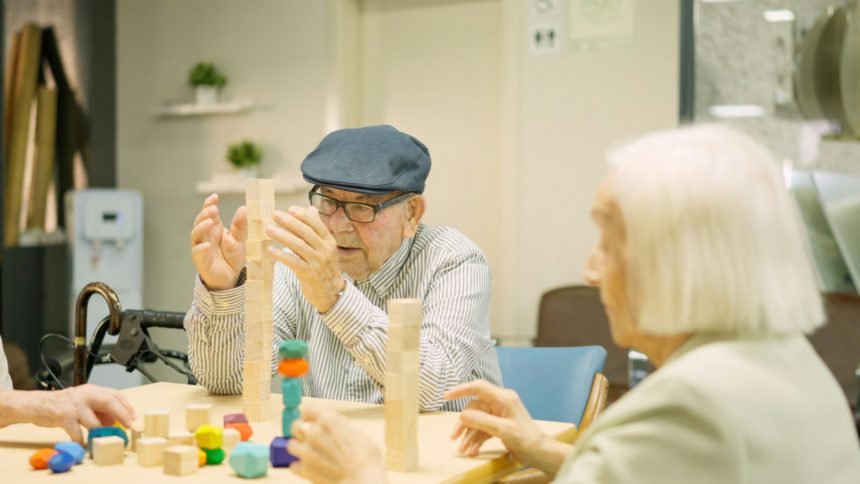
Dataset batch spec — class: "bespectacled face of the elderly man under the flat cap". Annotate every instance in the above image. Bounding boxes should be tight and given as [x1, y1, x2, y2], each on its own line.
[319, 187, 423, 281]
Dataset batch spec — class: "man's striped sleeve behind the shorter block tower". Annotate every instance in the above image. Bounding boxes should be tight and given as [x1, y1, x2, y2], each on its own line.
[322, 251, 493, 411]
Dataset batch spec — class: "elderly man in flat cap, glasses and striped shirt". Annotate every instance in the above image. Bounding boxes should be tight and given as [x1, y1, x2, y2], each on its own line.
[185, 126, 500, 411]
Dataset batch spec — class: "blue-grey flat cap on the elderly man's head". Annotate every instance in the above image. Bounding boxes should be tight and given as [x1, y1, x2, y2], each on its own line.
[302, 125, 430, 195]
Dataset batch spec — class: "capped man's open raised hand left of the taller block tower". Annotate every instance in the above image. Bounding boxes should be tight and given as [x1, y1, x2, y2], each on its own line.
[191, 193, 247, 291]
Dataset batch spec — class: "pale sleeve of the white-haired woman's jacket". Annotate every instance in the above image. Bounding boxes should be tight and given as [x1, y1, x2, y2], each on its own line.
[555, 381, 747, 484]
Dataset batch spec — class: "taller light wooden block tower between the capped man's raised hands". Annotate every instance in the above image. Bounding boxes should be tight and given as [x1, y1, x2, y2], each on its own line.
[242, 179, 275, 422]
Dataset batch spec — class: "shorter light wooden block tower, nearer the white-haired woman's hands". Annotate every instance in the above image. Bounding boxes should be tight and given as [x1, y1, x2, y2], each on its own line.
[385, 299, 424, 472]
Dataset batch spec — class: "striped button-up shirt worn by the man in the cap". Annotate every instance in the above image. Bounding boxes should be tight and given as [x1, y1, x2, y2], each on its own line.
[185, 225, 501, 411]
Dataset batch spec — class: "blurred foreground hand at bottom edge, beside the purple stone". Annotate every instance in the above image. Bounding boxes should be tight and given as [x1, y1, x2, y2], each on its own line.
[288, 403, 385, 484]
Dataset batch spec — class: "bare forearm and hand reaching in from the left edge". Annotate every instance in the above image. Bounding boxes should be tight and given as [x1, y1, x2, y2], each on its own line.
[0, 332, 136, 442]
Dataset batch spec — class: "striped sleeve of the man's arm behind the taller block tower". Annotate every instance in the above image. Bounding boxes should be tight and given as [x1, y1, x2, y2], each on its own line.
[185, 264, 296, 395]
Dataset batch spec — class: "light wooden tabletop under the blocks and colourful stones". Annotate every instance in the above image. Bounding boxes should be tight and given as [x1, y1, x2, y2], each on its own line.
[0, 383, 575, 484]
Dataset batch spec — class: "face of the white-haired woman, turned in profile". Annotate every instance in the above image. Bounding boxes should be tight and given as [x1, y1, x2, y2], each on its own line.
[584, 175, 638, 348]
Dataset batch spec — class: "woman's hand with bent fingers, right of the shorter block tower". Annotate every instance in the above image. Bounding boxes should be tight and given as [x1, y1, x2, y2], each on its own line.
[444, 381, 570, 474]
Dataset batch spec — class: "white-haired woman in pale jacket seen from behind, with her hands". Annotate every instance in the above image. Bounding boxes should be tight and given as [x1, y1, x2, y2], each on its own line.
[284, 126, 860, 483]
